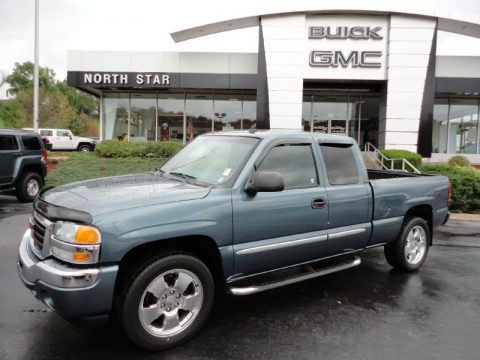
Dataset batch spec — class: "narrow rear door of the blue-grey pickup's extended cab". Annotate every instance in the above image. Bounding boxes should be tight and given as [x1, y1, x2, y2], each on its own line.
[320, 143, 372, 255]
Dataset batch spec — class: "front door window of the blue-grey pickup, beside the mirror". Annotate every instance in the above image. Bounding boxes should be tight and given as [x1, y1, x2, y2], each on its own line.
[259, 144, 318, 189]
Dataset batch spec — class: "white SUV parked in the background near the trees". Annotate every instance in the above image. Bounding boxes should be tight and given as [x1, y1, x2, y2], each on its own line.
[24, 128, 97, 152]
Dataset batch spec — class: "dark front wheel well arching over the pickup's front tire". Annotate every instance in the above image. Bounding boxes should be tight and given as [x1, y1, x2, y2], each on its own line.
[115, 236, 225, 295]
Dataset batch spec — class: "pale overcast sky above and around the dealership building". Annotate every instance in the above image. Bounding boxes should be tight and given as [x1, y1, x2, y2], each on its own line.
[0, 0, 480, 98]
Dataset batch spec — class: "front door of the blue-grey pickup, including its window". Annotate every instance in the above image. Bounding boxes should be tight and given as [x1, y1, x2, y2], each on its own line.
[232, 140, 328, 275]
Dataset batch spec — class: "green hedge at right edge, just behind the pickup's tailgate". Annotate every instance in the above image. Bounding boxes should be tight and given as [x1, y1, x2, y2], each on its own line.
[422, 164, 480, 212]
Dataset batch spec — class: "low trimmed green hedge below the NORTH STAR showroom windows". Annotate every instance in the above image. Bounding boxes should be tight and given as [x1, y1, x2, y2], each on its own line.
[95, 140, 182, 159]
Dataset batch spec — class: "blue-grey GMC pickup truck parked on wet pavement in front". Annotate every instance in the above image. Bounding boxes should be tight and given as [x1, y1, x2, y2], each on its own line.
[18, 130, 449, 350]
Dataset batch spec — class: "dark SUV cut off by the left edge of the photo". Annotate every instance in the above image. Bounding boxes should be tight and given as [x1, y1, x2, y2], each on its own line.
[0, 129, 47, 202]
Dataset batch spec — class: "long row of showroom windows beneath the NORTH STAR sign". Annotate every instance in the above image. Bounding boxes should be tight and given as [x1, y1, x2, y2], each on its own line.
[101, 90, 257, 143]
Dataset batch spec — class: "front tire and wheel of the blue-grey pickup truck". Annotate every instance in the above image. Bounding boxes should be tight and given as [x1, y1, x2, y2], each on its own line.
[116, 255, 214, 350]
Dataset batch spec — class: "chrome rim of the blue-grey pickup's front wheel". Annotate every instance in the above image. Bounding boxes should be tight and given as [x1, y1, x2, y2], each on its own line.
[138, 269, 204, 337]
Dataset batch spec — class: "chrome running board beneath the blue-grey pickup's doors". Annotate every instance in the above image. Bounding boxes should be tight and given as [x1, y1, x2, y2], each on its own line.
[228, 256, 362, 295]
